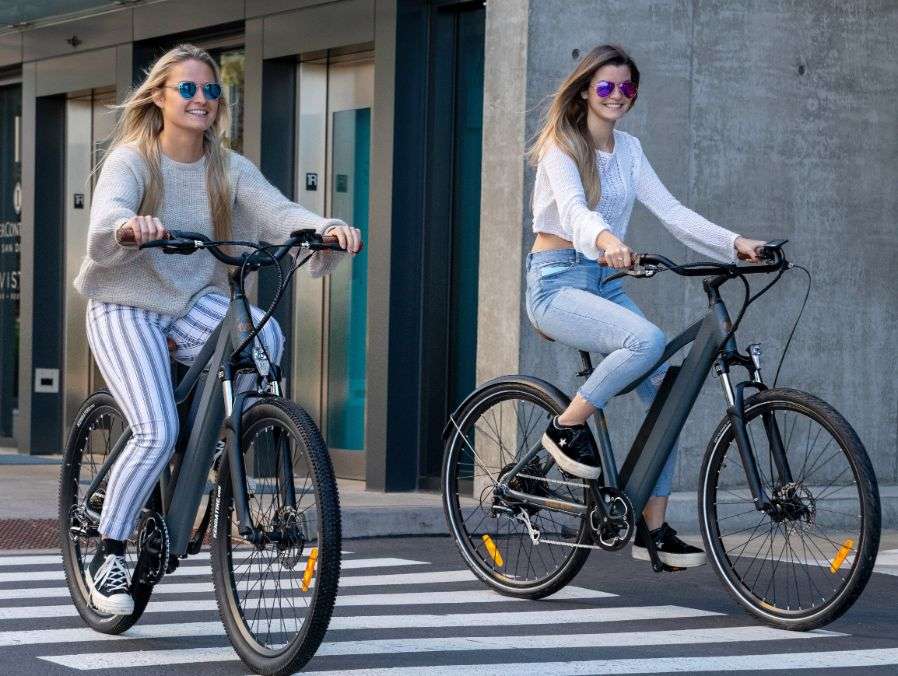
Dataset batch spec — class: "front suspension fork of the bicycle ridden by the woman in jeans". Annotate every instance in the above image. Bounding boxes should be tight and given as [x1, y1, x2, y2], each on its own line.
[714, 343, 792, 512]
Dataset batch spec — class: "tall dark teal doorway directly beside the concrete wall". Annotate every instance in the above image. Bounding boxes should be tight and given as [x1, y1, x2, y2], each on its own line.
[420, 2, 486, 487]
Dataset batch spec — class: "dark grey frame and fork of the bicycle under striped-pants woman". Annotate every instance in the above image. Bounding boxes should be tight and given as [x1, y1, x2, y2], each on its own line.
[85, 269, 284, 557]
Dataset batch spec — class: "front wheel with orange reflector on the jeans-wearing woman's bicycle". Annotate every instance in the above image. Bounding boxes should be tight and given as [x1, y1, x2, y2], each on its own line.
[699, 389, 880, 630]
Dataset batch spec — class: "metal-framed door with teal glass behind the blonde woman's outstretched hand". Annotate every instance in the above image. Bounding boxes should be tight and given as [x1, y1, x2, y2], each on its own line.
[293, 52, 374, 479]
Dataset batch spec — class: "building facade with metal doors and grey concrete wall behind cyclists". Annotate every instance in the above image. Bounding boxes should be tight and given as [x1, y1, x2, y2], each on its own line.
[0, 0, 898, 490]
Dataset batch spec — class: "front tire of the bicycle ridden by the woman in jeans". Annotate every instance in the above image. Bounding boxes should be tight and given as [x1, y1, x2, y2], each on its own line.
[698, 388, 881, 631]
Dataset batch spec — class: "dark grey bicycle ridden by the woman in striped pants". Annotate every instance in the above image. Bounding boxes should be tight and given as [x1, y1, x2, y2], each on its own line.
[59, 230, 340, 674]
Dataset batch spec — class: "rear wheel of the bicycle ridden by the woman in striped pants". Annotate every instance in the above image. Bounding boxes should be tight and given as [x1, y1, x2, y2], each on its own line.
[59, 390, 153, 634]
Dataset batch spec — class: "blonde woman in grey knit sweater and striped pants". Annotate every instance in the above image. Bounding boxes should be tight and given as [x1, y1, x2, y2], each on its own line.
[75, 45, 360, 615]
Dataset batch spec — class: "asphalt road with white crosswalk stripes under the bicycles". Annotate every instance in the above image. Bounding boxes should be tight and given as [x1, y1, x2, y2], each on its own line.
[0, 538, 898, 676]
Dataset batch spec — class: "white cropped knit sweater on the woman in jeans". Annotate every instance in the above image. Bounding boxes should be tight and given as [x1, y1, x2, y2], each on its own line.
[533, 129, 739, 262]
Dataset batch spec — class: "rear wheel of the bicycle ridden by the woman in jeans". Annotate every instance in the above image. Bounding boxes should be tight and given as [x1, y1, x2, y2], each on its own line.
[442, 376, 591, 599]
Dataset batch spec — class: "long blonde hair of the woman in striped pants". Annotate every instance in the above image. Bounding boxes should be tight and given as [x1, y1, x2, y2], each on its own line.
[110, 44, 231, 239]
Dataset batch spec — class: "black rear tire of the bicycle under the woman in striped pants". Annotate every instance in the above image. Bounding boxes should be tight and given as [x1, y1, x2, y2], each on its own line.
[59, 390, 153, 634]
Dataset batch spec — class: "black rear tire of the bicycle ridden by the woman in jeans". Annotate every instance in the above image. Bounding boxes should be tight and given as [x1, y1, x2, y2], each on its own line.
[441, 376, 591, 599]
